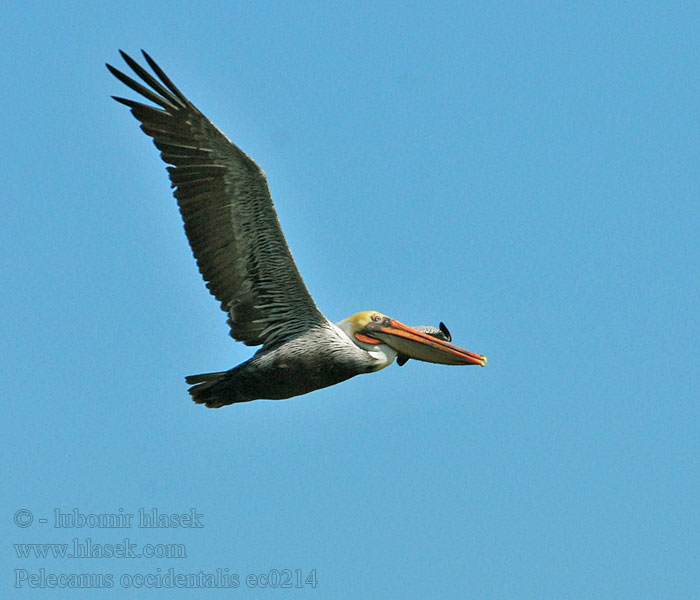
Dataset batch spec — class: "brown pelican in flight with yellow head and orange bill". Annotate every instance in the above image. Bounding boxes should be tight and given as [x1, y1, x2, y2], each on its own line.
[107, 51, 486, 408]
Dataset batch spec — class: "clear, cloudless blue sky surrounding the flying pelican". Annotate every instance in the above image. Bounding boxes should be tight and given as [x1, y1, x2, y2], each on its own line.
[0, 1, 700, 599]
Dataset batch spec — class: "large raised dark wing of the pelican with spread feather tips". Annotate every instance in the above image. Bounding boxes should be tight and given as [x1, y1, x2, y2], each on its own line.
[107, 51, 326, 346]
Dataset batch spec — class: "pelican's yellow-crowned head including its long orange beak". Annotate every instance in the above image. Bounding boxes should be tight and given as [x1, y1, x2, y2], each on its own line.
[338, 310, 486, 367]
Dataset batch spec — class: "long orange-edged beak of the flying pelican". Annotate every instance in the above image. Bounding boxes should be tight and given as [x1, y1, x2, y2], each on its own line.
[365, 319, 486, 367]
